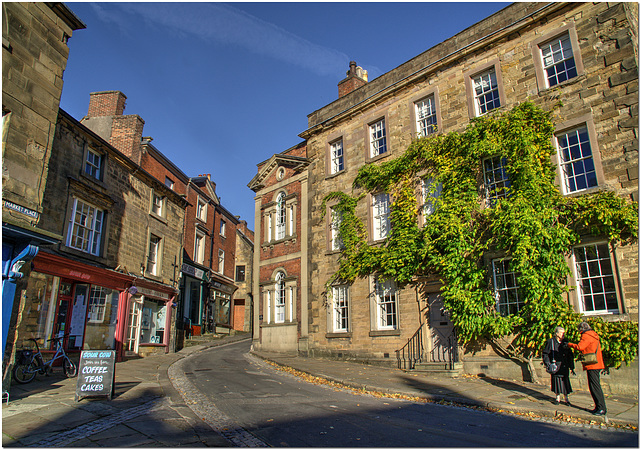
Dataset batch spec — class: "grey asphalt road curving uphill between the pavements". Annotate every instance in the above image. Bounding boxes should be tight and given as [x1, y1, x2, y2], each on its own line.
[176, 341, 638, 447]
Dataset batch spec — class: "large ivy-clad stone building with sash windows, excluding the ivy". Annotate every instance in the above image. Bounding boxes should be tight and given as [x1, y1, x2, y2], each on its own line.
[249, 3, 638, 388]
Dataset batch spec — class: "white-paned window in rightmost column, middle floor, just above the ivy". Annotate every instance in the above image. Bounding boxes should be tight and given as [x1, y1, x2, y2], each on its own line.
[556, 126, 598, 194]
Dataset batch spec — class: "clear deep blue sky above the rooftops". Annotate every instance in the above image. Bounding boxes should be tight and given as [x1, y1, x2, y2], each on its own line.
[61, 2, 508, 224]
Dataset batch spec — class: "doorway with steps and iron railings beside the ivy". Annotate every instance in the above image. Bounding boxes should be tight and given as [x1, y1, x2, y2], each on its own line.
[428, 293, 458, 362]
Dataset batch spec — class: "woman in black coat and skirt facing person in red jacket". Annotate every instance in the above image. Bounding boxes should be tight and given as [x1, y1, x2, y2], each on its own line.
[542, 326, 576, 405]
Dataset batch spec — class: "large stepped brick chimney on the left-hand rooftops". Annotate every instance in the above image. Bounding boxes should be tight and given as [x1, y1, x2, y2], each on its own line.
[81, 90, 144, 164]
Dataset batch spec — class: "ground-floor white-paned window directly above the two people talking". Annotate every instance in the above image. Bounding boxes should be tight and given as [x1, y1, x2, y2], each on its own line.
[571, 242, 620, 315]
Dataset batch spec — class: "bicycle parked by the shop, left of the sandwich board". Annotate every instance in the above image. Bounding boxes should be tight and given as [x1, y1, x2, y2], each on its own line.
[12, 335, 78, 384]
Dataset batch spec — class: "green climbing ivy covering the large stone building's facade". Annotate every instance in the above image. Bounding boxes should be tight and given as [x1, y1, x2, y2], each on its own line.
[323, 102, 638, 380]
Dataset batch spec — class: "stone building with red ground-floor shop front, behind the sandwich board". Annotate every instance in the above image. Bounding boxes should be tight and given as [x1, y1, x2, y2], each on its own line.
[12, 110, 186, 360]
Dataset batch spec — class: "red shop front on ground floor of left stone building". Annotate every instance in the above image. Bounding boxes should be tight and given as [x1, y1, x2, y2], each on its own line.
[29, 251, 176, 361]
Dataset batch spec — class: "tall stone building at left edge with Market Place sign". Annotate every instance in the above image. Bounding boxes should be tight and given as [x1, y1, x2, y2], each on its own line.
[2, 2, 85, 373]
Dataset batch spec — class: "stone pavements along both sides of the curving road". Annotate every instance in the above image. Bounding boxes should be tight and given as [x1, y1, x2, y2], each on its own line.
[2, 334, 638, 447]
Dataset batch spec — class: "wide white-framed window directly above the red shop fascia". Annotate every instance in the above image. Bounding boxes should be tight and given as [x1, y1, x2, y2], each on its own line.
[67, 198, 106, 256]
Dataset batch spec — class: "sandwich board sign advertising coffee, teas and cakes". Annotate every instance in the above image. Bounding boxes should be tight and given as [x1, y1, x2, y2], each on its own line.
[76, 350, 116, 402]
